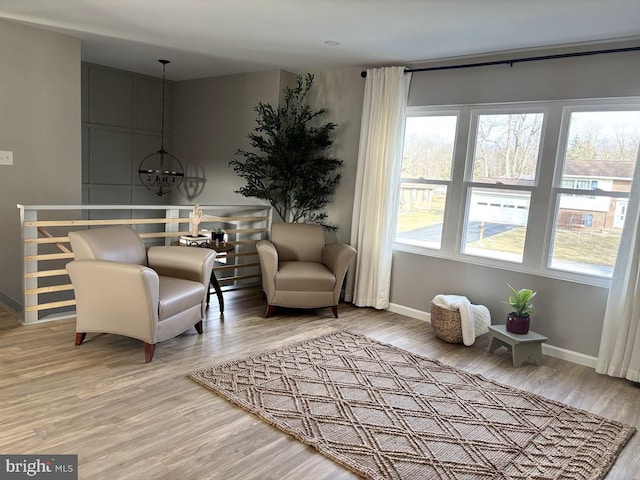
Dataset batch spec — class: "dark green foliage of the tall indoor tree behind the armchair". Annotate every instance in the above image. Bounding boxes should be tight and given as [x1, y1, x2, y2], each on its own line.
[229, 74, 342, 228]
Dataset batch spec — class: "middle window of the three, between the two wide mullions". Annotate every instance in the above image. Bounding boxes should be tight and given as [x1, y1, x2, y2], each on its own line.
[461, 112, 544, 263]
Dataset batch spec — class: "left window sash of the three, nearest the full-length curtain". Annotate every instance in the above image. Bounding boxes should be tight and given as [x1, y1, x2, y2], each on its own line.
[396, 114, 457, 249]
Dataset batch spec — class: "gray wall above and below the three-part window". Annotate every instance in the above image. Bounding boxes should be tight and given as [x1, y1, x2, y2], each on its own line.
[391, 40, 640, 356]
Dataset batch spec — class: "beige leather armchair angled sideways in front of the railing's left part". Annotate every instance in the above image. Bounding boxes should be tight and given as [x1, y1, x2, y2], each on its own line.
[67, 226, 216, 362]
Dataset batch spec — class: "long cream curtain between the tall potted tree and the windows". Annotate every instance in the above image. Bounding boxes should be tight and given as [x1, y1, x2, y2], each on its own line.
[346, 67, 411, 309]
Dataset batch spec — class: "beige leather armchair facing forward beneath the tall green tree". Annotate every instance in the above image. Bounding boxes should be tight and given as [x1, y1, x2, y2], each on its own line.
[256, 223, 356, 318]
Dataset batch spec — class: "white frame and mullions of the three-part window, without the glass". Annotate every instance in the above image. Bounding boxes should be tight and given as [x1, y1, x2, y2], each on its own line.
[393, 96, 640, 287]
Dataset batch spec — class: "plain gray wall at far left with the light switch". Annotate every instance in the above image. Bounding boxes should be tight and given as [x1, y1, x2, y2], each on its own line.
[0, 20, 81, 309]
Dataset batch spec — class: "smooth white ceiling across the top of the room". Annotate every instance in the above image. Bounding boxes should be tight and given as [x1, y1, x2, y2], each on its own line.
[0, 0, 640, 80]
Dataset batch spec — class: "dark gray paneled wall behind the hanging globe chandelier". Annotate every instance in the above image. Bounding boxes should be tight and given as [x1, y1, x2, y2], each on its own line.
[82, 63, 180, 205]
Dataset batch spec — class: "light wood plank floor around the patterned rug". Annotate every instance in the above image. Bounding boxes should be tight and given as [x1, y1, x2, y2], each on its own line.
[0, 289, 640, 480]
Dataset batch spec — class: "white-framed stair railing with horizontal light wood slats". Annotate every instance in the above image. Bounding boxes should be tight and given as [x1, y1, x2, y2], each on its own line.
[18, 205, 272, 324]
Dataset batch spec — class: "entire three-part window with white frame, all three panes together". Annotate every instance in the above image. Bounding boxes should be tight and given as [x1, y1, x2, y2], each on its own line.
[395, 98, 640, 285]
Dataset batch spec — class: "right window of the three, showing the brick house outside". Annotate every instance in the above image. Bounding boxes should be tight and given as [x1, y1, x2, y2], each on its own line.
[549, 108, 640, 277]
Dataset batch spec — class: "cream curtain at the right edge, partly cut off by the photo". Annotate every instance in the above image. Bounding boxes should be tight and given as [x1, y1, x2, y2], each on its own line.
[596, 146, 640, 382]
